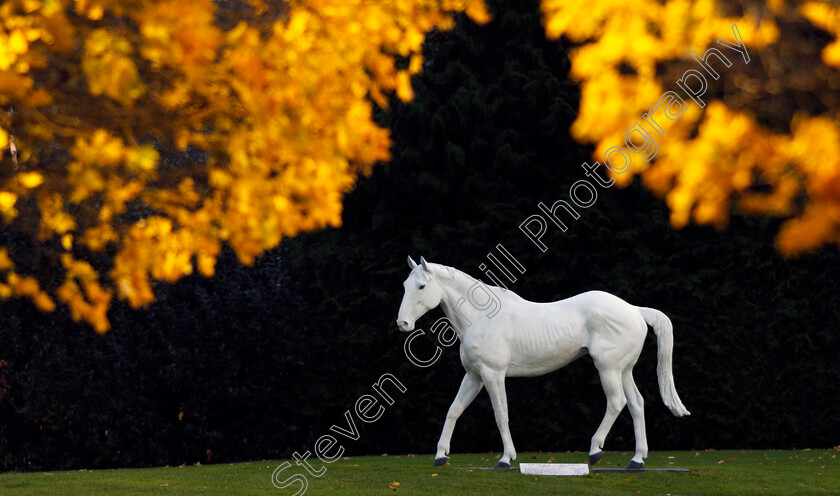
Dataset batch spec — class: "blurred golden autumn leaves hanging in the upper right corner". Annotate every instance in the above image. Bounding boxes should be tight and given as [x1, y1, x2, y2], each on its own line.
[541, 0, 840, 255]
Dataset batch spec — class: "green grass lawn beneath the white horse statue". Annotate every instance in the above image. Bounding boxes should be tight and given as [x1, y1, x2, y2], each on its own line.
[0, 450, 840, 496]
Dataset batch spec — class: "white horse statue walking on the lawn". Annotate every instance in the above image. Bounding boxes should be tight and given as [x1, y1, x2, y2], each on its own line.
[397, 257, 689, 469]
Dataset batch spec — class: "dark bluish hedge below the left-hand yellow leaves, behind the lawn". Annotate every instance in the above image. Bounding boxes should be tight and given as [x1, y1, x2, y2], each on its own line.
[0, 252, 311, 469]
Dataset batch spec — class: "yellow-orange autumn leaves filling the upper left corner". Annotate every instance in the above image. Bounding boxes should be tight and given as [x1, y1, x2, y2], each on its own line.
[0, 0, 490, 332]
